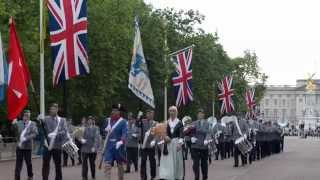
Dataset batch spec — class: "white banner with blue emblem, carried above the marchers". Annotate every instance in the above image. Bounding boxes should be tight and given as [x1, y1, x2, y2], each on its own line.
[128, 17, 155, 108]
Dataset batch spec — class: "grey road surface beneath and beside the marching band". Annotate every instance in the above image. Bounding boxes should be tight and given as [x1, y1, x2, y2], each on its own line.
[0, 137, 320, 180]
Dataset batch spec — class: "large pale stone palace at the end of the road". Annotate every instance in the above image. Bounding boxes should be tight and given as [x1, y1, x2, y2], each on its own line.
[260, 79, 320, 128]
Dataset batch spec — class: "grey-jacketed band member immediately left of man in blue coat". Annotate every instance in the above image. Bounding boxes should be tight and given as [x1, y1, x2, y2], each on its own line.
[81, 116, 100, 180]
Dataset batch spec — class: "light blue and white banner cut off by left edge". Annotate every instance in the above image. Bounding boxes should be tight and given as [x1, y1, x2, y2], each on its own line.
[0, 33, 8, 102]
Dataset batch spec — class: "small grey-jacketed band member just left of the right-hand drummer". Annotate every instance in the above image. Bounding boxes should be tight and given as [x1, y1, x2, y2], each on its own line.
[213, 119, 226, 160]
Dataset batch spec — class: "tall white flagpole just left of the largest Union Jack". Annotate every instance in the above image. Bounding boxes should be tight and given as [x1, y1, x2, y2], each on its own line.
[40, 0, 45, 118]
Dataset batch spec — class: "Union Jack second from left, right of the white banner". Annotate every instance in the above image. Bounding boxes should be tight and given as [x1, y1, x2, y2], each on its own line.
[171, 47, 193, 107]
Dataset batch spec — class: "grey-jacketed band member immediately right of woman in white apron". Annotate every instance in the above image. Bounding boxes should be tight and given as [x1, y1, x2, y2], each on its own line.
[185, 109, 210, 180]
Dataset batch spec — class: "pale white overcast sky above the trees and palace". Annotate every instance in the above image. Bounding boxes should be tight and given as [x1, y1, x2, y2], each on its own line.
[144, 0, 320, 85]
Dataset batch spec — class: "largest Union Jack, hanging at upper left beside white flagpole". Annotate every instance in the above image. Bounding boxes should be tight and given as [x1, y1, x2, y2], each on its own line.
[47, 0, 89, 85]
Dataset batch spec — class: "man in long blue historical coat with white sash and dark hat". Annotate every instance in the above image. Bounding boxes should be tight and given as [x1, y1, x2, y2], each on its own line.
[103, 104, 128, 180]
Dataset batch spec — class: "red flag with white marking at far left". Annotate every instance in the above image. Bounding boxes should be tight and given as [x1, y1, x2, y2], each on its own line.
[7, 18, 30, 120]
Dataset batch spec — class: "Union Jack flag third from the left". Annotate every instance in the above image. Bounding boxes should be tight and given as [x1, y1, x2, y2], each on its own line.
[218, 76, 234, 114]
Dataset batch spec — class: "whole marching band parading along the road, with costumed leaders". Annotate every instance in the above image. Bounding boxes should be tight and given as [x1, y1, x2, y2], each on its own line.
[11, 103, 284, 180]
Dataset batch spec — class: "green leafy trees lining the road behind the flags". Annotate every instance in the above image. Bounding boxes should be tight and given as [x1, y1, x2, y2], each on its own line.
[0, 0, 266, 126]
